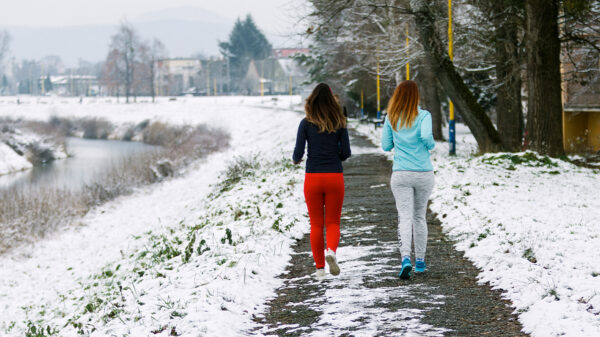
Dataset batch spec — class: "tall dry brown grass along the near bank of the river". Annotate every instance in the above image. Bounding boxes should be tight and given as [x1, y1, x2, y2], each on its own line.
[0, 123, 229, 254]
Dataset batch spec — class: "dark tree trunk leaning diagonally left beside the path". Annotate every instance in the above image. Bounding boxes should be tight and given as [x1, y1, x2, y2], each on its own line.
[410, 0, 504, 152]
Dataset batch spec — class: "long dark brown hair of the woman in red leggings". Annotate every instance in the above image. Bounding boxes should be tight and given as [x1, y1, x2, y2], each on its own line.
[304, 83, 346, 132]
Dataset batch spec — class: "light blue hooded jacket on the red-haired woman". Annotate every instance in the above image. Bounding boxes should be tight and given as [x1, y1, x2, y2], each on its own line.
[381, 107, 435, 171]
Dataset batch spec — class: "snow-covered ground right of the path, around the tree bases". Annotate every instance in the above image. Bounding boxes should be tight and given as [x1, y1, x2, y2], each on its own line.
[354, 119, 600, 336]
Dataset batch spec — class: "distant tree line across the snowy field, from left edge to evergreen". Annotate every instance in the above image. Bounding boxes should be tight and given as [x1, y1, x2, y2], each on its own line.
[0, 15, 272, 98]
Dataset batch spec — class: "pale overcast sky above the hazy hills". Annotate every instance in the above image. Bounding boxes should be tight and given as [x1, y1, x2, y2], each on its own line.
[0, 0, 306, 34]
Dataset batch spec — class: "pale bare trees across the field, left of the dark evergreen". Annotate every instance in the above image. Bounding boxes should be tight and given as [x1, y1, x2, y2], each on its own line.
[101, 22, 166, 103]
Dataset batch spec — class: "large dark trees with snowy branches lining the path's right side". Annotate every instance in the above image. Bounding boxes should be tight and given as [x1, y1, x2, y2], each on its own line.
[302, 0, 600, 156]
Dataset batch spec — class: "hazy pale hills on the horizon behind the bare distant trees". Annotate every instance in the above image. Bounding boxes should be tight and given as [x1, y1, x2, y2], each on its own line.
[6, 6, 233, 66]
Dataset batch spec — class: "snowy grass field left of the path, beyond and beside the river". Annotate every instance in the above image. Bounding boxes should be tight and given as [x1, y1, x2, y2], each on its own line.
[0, 97, 308, 336]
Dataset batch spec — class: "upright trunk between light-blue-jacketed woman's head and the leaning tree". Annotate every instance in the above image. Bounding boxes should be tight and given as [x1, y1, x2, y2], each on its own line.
[417, 57, 444, 140]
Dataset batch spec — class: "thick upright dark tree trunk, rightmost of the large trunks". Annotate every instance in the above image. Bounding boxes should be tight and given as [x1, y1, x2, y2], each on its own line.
[525, 0, 564, 157]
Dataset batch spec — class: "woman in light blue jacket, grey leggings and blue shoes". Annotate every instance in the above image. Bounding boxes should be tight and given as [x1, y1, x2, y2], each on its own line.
[381, 81, 435, 279]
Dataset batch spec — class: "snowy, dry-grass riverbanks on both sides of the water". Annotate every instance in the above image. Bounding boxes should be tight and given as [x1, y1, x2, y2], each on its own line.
[0, 98, 251, 254]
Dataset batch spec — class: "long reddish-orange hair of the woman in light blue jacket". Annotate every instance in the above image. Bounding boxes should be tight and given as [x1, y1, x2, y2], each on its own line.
[387, 81, 419, 131]
